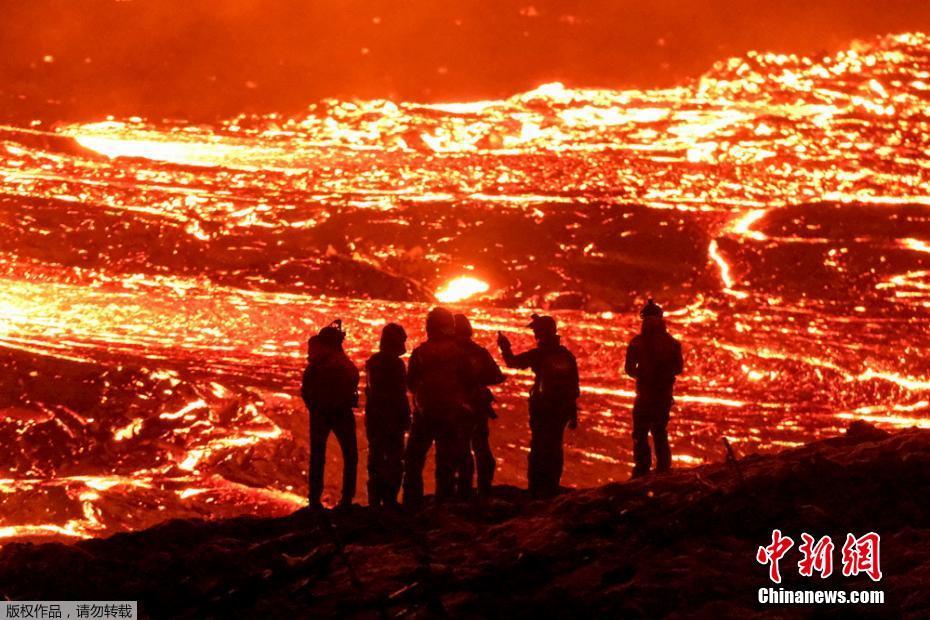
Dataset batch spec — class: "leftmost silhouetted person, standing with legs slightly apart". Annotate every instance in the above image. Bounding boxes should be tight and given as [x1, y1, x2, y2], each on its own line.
[300, 321, 358, 508]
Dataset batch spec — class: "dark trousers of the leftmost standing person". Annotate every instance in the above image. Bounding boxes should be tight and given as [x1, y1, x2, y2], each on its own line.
[310, 409, 358, 506]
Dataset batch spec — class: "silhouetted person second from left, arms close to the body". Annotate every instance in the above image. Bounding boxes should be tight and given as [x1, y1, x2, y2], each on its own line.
[365, 323, 410, 506]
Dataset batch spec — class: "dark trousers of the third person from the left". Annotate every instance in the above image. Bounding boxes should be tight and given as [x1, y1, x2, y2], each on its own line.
[404, 411, 468, 505]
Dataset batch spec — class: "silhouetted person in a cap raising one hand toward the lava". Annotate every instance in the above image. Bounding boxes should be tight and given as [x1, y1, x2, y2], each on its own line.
[497, 314, 580, 497]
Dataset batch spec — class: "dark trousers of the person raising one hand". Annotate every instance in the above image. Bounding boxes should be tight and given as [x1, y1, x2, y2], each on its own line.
[527, 401, 571, 497]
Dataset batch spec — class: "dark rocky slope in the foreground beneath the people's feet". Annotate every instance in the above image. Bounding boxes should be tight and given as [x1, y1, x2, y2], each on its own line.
[0, 423, 930, 618]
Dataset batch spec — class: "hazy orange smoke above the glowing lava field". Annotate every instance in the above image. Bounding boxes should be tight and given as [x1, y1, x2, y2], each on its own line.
[0, 0, 930, 120]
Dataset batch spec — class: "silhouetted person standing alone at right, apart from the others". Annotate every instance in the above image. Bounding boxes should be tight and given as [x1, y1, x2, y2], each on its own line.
[624, 299, 683, 478]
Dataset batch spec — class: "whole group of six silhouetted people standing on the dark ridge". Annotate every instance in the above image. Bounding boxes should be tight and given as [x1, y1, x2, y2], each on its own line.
[301, 300, 682, 508]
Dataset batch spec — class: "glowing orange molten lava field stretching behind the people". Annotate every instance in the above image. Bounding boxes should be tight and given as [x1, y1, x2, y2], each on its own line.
[0, 33, 930, 540]
